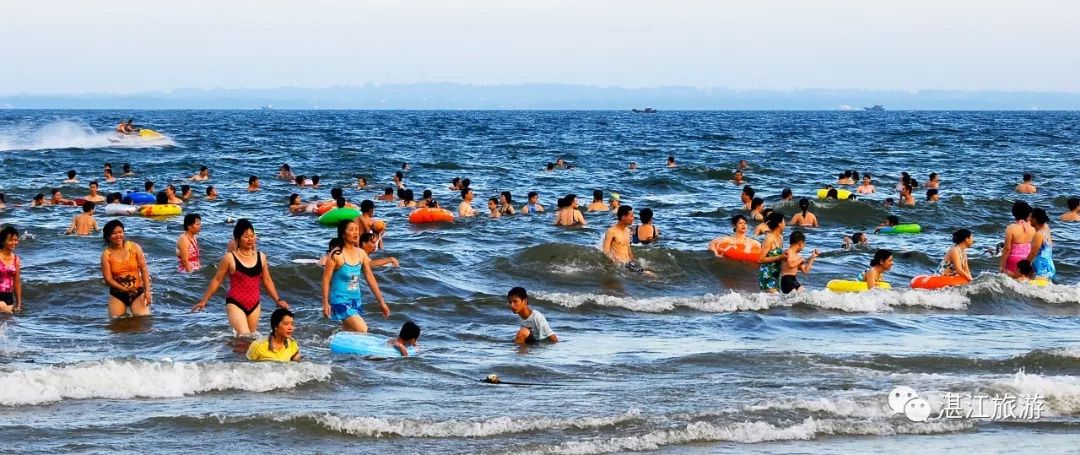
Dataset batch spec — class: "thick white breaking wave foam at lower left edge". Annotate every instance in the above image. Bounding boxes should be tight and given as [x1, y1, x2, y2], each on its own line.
[0, 360, 330, 406]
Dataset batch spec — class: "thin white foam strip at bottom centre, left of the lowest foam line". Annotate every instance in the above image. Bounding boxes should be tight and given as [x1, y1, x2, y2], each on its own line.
[289, 411, 640, 438]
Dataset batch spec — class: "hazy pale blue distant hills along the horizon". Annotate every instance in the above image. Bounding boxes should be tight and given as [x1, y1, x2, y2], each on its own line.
[0, 83, 1080, 109]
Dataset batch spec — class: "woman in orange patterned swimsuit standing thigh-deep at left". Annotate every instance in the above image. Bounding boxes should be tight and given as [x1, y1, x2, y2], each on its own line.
[102, 219, 150, 318]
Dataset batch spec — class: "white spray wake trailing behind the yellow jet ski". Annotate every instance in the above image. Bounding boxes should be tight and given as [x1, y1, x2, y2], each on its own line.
[0, 120, 176, 151]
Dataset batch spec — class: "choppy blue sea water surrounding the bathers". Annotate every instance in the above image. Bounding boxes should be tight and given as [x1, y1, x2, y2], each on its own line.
[0, 110, 1080, 454]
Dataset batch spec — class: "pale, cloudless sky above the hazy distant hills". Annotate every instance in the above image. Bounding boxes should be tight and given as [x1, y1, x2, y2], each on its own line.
[0, 0, 1080, 94]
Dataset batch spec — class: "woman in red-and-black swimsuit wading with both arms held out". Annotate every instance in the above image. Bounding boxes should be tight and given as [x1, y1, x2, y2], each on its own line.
[191, 218, 288, 336]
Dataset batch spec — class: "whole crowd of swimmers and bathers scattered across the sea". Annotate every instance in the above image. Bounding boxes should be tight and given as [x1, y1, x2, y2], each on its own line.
[0, 157, 1080, 360]
